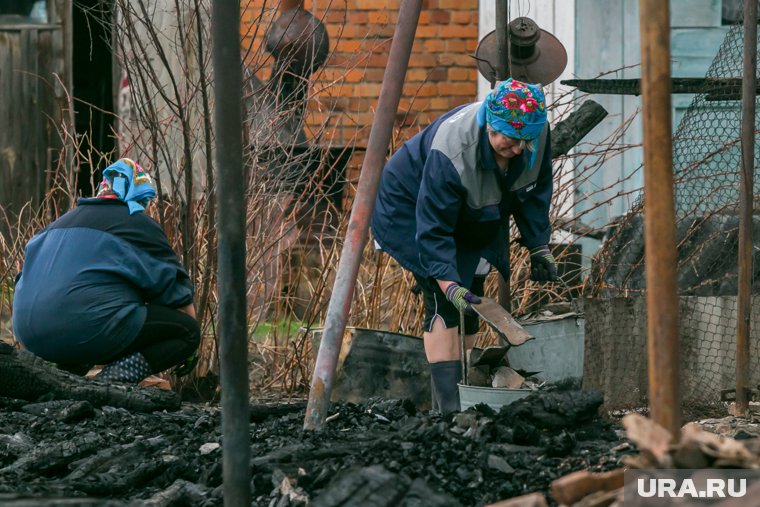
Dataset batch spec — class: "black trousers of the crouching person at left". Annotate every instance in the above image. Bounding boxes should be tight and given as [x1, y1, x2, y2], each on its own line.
[107, 304, 201, 373]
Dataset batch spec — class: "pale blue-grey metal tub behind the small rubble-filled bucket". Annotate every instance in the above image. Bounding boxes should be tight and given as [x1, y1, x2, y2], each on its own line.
[507, 314, 585, 382]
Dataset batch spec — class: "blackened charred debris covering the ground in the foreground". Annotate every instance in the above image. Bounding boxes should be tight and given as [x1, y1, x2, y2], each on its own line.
[0, 389, 634, 507]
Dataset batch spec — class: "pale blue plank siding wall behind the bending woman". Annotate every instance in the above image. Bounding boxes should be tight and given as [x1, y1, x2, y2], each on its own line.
[575, 0, 728, 226]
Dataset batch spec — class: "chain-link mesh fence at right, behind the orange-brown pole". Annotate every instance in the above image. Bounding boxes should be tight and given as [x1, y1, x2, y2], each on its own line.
[584, 15, 760, 419]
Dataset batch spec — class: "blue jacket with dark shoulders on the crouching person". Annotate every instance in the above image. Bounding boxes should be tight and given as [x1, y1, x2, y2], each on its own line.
[13, 199, 193, 364]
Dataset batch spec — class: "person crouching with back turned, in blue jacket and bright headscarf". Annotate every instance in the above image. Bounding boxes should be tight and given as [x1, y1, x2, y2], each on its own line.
[13, 158, 200, 383]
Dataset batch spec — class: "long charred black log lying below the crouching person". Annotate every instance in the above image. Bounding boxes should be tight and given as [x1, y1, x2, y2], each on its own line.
[0, 343, 181, 412]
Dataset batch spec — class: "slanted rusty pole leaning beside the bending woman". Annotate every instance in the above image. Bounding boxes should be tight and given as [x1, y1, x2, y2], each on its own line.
[304, 0, 422, 430]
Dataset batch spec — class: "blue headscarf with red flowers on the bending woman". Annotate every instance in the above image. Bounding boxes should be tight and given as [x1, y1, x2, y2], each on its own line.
[478, 78, 546, 141]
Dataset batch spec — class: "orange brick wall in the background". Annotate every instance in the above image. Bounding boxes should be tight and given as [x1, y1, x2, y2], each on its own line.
[242, 0, 478, 153]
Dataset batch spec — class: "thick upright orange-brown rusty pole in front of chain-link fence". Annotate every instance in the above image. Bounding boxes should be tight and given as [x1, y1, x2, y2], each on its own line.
[639, 0, 681, 439]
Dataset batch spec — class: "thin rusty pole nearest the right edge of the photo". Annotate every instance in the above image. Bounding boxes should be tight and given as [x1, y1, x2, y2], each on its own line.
[736, 0, 757, 413]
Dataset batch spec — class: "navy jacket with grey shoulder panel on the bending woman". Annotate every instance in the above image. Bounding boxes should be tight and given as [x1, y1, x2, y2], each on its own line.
[372, 102, 552, 286]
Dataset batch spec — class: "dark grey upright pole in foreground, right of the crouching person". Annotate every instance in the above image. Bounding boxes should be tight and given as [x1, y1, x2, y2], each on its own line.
[211, 0, 251, 507]
